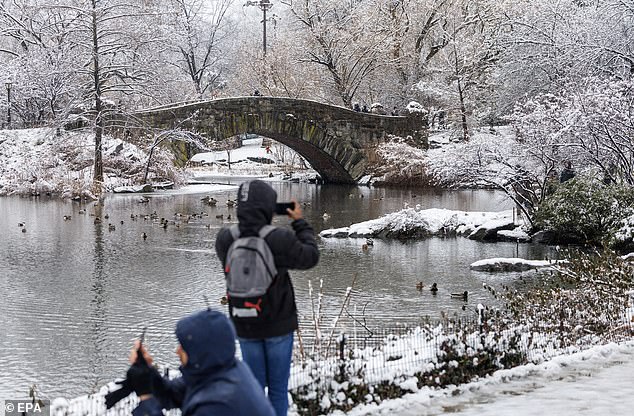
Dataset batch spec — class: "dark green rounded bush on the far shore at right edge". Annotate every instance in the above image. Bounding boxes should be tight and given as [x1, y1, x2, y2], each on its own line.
[535, 176, 634, 245]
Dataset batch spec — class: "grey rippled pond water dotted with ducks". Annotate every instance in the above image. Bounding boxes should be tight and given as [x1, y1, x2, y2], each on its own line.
[0, 182, 548, 398]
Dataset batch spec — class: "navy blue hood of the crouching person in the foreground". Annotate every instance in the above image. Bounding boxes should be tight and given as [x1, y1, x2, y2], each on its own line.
[176, 310, 236, 384]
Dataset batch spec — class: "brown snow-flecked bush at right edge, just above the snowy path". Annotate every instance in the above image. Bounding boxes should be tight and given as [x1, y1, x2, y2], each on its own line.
[502, 250, 634, 346]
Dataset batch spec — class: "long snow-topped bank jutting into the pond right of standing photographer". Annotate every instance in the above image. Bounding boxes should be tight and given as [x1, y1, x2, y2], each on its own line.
[319, 208, 528, 240]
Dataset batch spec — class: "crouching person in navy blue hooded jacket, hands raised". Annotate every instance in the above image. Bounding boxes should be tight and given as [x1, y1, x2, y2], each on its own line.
[127, 309, 275, 416]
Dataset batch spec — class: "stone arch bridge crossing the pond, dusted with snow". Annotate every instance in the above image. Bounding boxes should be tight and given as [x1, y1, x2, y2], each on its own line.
[111, 97, 427, 183]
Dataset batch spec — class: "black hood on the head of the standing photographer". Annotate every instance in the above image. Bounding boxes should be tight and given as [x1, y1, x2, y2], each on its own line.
[238, 180, 277, 236]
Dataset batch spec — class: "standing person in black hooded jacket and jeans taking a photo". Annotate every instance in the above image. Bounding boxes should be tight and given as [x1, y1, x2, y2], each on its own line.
[216, 180, 319, 416]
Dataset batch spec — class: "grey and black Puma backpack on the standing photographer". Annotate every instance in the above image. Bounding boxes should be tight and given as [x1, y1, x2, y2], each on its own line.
[225, 225, 277, 322]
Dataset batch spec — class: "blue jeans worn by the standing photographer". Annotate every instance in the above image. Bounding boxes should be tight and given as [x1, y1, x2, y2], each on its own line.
[238, 332, 293, 416]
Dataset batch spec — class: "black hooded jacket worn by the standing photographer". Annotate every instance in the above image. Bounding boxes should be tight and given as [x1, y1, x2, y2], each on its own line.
[216, 180, 319, 339]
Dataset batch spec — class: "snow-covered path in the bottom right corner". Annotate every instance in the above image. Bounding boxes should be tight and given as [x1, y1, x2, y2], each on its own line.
[340, 343, 634, 416]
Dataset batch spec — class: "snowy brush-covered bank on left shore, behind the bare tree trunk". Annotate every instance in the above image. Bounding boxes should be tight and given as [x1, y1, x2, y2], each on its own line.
[0, 128, 182, 197]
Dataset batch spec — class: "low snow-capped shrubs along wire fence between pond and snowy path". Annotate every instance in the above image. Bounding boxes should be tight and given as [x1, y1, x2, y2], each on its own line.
[291, 321, 527, 415]
